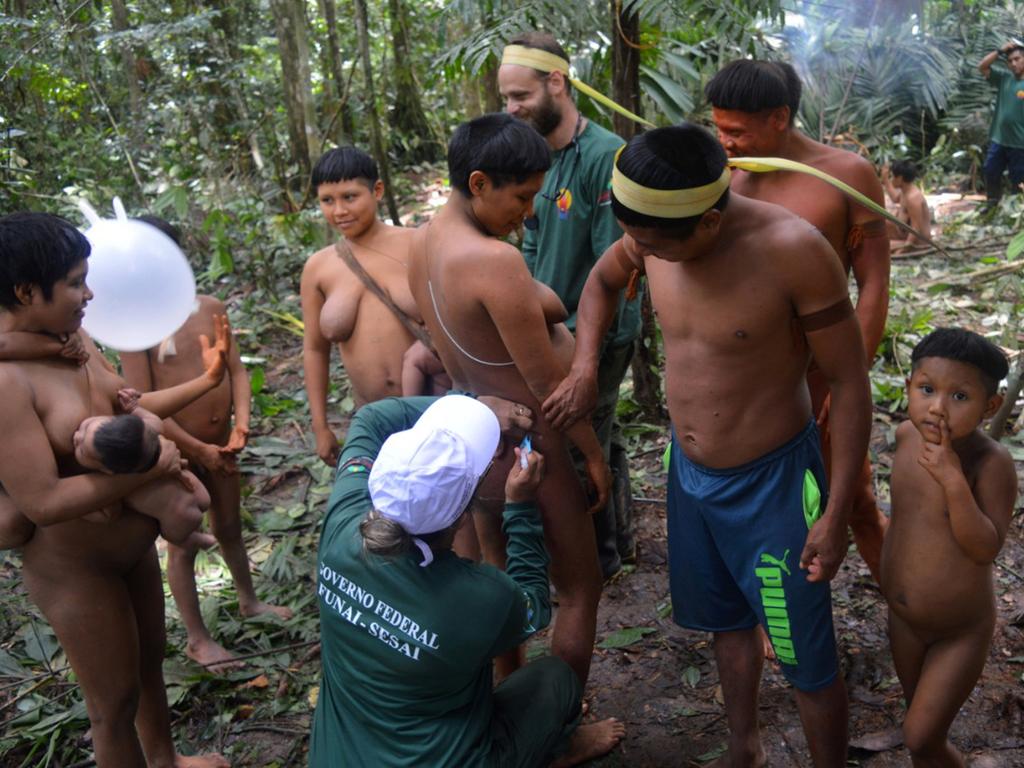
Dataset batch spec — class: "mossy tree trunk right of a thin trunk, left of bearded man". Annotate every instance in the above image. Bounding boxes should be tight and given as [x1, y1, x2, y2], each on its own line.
[388, 0, 438, 163]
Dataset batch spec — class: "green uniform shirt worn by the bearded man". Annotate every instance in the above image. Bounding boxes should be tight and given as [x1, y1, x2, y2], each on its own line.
[522, 122, 640, 344]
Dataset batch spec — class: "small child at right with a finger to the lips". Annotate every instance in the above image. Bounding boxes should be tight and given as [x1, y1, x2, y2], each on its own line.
[882, 328, 1017, 766]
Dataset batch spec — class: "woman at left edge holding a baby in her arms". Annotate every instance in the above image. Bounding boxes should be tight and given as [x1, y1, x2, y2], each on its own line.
[0, 214, 227, 768]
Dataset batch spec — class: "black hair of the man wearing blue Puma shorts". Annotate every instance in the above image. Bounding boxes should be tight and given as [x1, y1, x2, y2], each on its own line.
[611, 123, 729, 240]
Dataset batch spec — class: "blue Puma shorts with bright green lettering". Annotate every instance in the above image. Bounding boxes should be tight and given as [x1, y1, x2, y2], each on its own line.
[669, 420, 839, 691]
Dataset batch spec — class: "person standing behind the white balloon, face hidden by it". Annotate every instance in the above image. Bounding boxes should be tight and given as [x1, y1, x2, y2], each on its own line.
[121, 217, 292, 673]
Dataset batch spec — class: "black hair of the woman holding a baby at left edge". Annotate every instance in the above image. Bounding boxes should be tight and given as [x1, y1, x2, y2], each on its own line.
[0, 213, 91, 308]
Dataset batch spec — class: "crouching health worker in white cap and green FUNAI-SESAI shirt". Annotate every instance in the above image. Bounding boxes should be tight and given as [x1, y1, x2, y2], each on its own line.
[309, 395, 624, 768]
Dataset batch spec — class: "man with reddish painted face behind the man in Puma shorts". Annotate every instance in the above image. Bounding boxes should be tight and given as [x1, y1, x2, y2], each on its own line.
[705, 59, 889, 581]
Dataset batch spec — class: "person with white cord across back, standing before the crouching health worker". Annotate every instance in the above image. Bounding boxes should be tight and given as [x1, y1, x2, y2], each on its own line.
[410, 115, 610, 682]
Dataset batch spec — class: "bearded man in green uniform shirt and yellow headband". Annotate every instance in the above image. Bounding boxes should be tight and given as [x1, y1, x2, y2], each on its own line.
[498, 32, 640, 579]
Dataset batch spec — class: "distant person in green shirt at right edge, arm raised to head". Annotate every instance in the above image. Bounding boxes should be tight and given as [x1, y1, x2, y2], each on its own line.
[978, 40, 1024, 206]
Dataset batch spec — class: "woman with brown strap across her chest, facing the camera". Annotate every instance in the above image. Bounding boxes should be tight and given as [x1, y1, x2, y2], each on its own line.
[300, 146, 421, 467]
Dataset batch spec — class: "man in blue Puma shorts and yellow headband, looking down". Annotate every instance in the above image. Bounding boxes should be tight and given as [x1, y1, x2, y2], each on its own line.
[544, 124, 870, 768]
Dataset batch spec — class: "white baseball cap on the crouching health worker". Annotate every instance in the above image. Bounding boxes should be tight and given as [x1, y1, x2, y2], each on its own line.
[370, 394, 501, 565]
